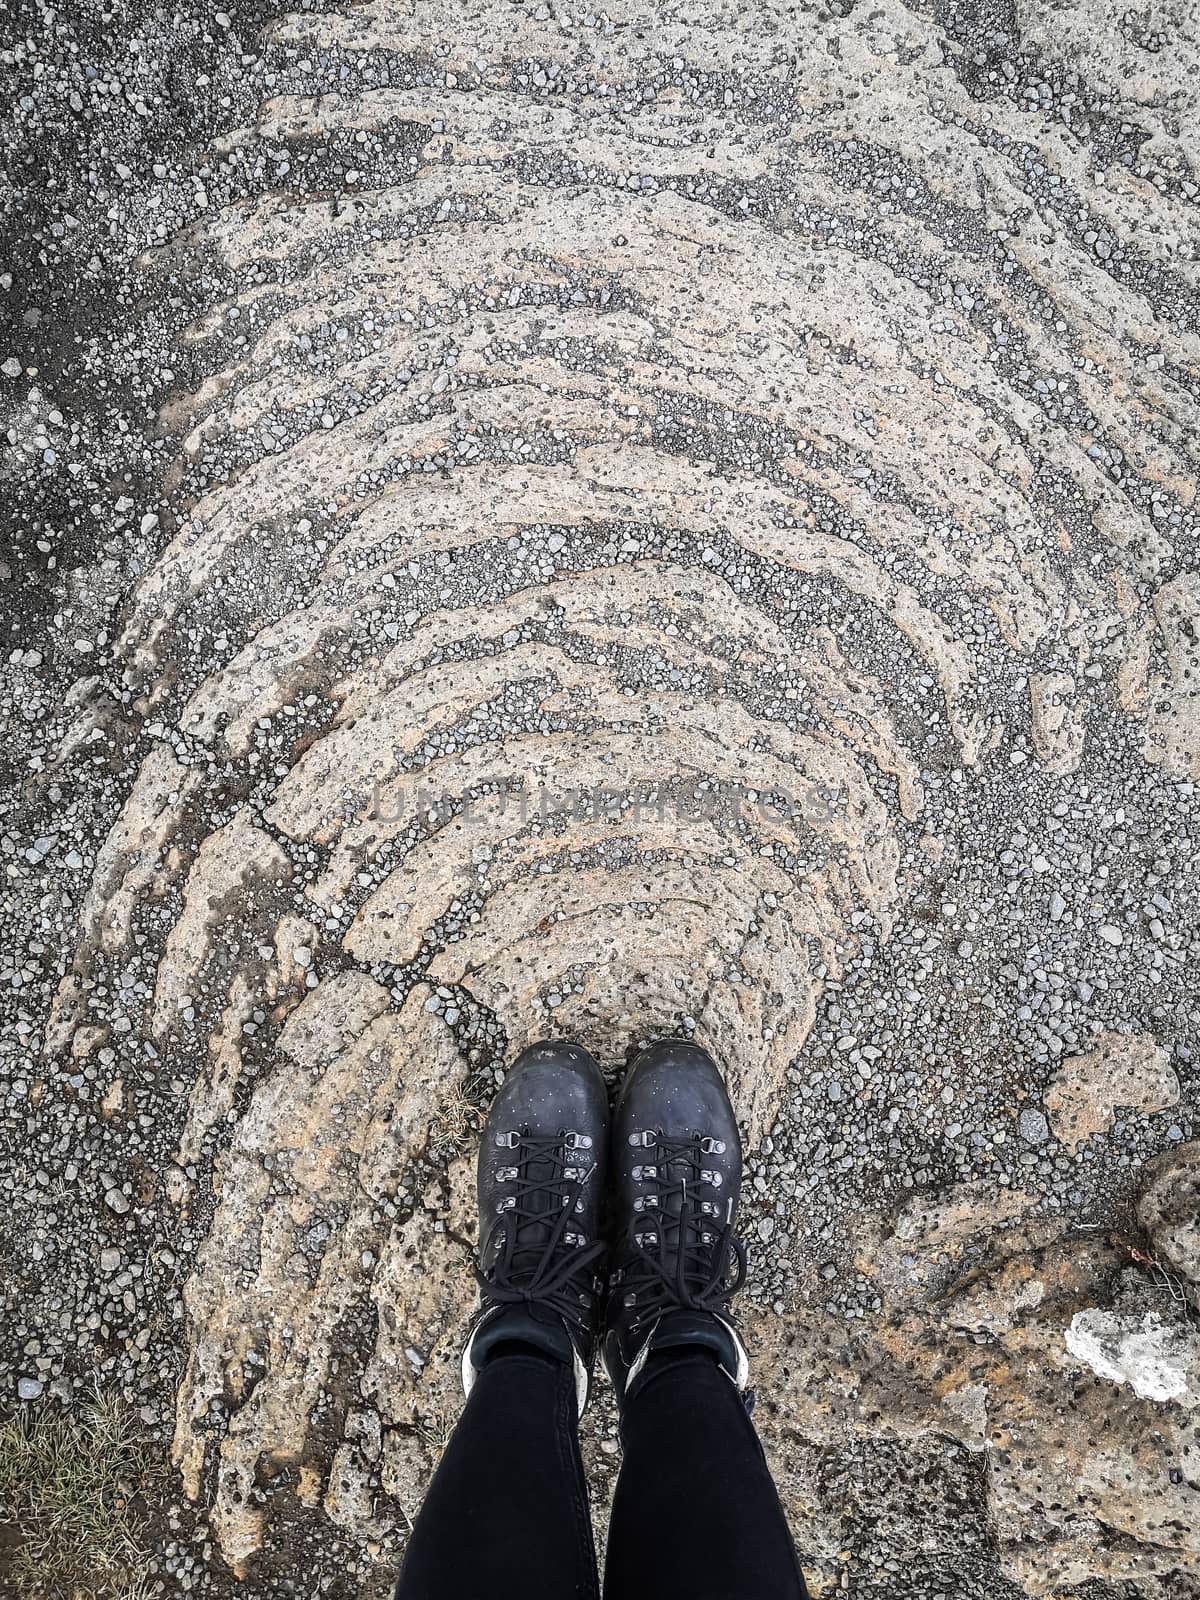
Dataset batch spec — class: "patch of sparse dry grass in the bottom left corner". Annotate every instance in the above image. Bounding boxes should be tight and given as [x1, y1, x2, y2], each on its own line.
[0, 1395, 157, 1600]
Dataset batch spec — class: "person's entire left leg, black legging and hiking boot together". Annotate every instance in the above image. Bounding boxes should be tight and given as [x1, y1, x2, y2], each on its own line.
[395, 1040, 608, 1600]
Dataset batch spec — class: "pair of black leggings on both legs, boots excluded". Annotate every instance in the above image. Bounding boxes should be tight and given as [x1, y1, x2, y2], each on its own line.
[395, 1350, 808, 1600]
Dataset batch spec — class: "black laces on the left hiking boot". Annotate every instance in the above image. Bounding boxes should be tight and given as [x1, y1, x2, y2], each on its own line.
[475, 1133, 605, 1330]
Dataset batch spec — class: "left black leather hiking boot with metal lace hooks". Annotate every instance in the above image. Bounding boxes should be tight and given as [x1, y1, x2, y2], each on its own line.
[462, 1040, 608, 1413]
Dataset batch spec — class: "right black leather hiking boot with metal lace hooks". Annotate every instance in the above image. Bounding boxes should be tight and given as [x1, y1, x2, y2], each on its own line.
[603, 1038, 747, 1398]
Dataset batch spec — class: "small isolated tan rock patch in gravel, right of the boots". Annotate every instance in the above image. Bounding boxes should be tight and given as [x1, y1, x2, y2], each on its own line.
[1046, 1034, 1179, 1144]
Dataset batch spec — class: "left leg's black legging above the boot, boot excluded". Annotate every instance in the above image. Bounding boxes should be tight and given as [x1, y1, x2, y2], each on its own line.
[395, 1344, 597, 1600]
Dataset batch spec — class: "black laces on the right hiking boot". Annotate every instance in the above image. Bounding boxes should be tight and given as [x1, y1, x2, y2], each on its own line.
[622, 1134, 746, 1325]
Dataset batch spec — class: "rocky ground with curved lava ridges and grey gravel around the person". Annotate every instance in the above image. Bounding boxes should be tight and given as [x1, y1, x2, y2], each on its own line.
[0, 0, 1200, 1600]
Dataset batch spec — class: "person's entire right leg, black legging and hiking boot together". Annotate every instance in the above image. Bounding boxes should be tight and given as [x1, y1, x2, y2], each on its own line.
[603, 1040, 805, 1600]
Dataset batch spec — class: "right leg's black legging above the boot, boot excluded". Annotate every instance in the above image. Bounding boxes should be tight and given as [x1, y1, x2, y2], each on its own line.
[605, 1346, 808, 1600]
